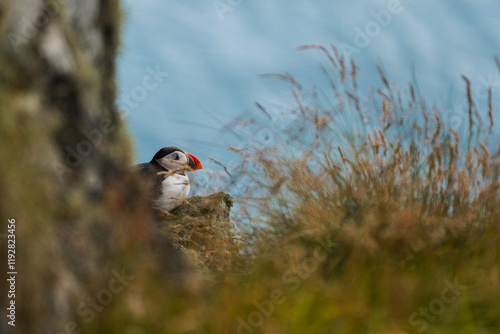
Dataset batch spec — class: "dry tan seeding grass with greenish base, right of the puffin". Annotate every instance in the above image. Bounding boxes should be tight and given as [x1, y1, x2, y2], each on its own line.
[198, 45, 500, 333]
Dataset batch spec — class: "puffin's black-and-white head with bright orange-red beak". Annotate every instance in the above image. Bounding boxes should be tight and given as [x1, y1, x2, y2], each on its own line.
[150, 146, 203, 170]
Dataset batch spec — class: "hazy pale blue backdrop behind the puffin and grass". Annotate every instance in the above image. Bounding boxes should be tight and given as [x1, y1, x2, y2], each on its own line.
[118, 0, 500, 185]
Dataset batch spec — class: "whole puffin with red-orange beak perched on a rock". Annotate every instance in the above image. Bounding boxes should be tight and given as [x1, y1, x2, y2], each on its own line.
[137, 146, 203, 212]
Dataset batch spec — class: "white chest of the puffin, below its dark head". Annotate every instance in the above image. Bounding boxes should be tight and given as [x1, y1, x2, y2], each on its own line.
[155, 174, 190, 211]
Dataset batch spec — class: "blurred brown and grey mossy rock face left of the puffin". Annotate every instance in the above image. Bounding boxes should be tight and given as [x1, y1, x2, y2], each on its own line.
[0, 0, 236, 333]
